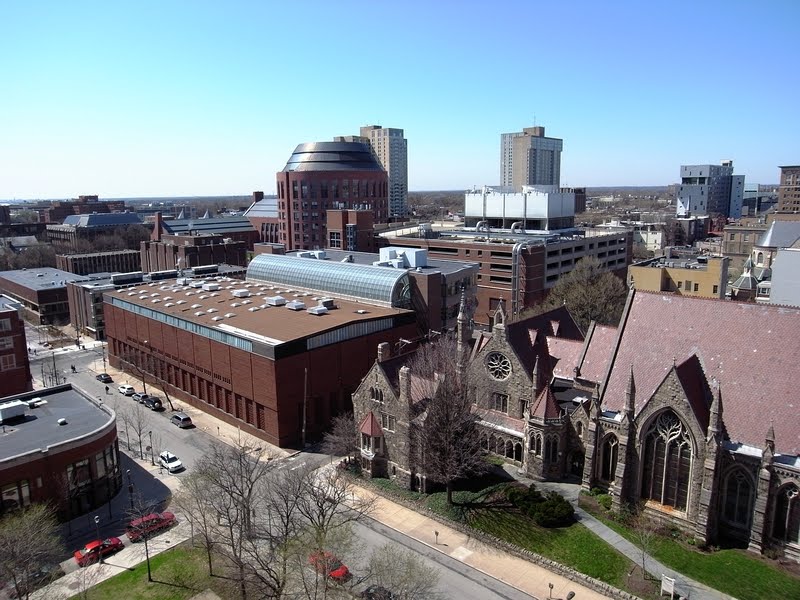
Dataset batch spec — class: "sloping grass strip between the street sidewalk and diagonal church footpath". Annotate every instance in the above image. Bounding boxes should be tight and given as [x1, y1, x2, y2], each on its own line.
[354, 475, 658, 598]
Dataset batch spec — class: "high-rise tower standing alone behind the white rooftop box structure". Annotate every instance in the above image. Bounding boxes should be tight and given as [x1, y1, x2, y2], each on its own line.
[500, 127, 564, 192]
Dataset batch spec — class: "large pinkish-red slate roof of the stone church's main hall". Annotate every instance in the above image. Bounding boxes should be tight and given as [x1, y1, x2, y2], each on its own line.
[602, 291, 800, 455]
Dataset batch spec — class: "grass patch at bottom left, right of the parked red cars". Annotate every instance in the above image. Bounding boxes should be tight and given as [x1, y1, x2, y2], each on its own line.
[73, 545, 236, 600]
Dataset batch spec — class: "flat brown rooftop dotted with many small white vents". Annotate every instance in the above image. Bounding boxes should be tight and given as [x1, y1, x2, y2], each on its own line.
[104, 276, 414, 357]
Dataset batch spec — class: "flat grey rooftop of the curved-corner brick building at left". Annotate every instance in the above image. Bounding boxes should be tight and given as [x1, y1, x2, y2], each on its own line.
[0, 384, 116, 468]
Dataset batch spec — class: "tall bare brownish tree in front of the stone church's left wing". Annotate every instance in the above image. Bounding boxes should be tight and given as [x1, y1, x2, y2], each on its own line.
[409, 336, 488, 504]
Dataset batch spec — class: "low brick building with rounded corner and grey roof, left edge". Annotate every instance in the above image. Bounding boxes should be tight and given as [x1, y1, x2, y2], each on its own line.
[0, 384, 122, 520]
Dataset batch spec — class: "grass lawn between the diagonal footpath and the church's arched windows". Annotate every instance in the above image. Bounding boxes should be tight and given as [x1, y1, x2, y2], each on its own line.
[581, 498, 800, 600]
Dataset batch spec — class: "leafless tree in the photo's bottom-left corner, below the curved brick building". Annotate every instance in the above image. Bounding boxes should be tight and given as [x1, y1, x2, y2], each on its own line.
[0, 504, 62, 598]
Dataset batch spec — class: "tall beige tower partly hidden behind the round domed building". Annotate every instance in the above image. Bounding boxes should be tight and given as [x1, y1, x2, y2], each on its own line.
[361, 125, 408, 217]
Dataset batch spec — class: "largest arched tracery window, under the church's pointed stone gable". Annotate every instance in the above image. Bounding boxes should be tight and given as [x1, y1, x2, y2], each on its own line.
[642, 411, 692, 510]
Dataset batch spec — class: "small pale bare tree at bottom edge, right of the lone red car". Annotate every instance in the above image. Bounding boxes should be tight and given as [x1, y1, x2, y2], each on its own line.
[367, 544, 443, 600]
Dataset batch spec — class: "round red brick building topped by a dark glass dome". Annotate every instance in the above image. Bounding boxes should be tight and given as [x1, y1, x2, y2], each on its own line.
[274, 141, 389, 250]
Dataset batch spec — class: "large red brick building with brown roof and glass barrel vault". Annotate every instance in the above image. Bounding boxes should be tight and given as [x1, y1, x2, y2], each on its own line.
[104, 254, 418, 447]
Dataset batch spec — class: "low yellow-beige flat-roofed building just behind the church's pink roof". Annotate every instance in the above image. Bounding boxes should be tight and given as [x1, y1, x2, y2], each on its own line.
[628, 256, 729, 298]
